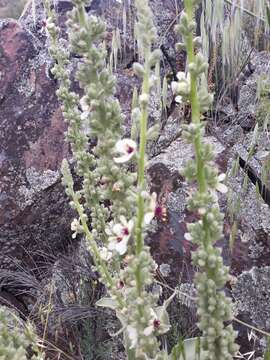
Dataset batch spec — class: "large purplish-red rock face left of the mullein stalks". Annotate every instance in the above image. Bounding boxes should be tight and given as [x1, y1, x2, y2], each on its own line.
[0, 16, 72, 269]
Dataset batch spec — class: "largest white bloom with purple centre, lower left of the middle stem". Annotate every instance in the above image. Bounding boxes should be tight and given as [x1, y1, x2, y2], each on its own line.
[106, 216, 134, 255]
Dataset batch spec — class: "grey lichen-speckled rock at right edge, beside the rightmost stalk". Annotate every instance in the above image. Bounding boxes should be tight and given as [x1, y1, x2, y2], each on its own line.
[228, 133, 270, 274]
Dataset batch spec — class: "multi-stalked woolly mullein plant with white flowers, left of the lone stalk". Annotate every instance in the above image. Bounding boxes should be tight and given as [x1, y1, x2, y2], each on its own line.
[44, 0, 173, 360]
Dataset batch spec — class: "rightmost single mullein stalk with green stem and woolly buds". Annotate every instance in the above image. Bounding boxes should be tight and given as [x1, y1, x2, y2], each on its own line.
[172, 0, 238, 360]
